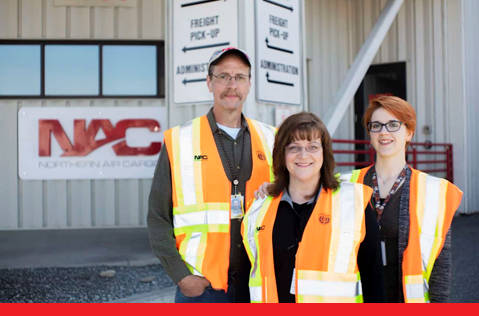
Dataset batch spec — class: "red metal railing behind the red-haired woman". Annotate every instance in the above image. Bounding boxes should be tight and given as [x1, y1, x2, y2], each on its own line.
[333, 139, 454, 182]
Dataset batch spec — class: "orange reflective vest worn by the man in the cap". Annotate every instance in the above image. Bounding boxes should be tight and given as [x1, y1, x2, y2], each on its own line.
[165, 116, 275, 291]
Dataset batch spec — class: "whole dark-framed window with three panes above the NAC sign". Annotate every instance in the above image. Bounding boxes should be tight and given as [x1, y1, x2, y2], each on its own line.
[0, 40, 165, 99]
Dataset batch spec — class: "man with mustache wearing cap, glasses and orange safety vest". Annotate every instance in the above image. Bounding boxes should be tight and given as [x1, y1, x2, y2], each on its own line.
[148, 47, 275, 303]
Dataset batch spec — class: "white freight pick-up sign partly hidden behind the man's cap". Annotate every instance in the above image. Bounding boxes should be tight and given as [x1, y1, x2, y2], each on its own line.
[172, 0, 238, 104]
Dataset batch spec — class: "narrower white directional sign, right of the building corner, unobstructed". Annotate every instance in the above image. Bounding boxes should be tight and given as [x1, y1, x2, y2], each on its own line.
[256, 0, 303, 105]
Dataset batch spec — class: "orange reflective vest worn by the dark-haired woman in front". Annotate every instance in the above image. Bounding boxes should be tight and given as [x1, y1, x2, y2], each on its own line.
[242, 182, 372, 303]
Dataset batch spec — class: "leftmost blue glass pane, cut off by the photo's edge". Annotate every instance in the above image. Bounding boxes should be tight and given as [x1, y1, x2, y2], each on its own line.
[0, 45, 41, 96]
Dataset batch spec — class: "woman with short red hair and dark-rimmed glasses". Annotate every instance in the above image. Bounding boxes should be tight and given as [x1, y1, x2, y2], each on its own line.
[341, 96, 462, 303]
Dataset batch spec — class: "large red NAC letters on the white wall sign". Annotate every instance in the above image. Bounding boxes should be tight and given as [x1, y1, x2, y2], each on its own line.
[38, 119, 161, 157]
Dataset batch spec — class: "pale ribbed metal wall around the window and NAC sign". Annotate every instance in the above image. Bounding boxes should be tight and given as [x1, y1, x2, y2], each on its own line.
[0, 0, 165, 230]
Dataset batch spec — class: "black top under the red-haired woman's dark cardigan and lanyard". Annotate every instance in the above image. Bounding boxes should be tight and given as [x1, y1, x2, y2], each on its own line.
[364, 169, 404, 303]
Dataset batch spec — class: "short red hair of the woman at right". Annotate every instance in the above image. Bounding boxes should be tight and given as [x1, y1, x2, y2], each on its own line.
[363, 96, 416, 135]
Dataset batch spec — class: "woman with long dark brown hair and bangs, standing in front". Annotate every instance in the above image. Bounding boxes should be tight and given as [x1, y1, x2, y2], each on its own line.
[242, 113, 385, 303]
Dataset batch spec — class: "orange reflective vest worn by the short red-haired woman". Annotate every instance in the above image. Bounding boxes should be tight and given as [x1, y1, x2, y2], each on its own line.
[341, 166, 463, 303]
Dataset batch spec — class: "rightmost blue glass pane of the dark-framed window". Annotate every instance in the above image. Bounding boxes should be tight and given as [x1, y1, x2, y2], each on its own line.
[103, 45, 158, 96]
